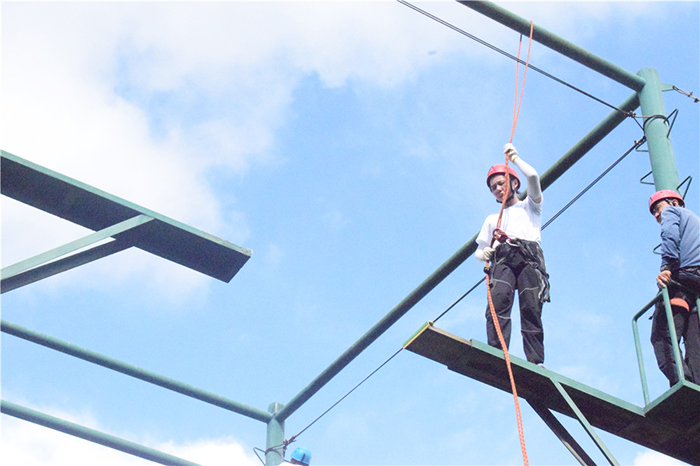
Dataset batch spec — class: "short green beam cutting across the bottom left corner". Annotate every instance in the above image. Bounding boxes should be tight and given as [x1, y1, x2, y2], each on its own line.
[0, 400, 199, 466]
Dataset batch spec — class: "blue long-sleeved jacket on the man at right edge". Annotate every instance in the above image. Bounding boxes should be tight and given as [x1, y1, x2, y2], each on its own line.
[661, 206, 700, 272]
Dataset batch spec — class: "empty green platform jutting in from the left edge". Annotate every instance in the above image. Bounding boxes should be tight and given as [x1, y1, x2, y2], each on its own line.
[0, 151, 252, 291]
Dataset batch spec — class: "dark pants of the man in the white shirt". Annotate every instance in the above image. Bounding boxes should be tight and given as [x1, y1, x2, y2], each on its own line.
[486, 244, 544, 364]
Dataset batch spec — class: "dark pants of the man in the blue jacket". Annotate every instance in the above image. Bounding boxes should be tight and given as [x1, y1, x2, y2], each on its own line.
[651, 269, 700, 386]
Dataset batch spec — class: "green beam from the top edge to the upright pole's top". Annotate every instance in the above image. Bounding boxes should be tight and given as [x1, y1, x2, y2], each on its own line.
[458, 0, 645, 91]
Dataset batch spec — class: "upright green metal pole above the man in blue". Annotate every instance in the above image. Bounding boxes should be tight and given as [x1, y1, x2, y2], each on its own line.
[637, 68, 678, 191]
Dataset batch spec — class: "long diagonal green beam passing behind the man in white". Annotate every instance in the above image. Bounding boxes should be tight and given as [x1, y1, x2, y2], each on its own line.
[277, 93, 639, 420]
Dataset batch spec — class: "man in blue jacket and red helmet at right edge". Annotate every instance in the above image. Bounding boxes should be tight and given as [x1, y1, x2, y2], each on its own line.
[649, 190, 700, 386]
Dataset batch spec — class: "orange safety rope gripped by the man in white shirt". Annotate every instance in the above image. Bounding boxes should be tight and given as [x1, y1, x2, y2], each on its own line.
[484, 21, 535, 466]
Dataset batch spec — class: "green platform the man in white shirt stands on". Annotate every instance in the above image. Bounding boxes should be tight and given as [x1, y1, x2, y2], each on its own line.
[405, 323, 700, 465]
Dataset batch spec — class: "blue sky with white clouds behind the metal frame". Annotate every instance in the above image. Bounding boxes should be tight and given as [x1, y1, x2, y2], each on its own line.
[0, 1, 700, 466]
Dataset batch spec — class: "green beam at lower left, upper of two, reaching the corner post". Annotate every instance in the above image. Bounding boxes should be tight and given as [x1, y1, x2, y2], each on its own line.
[0, 320, 272, 422]
